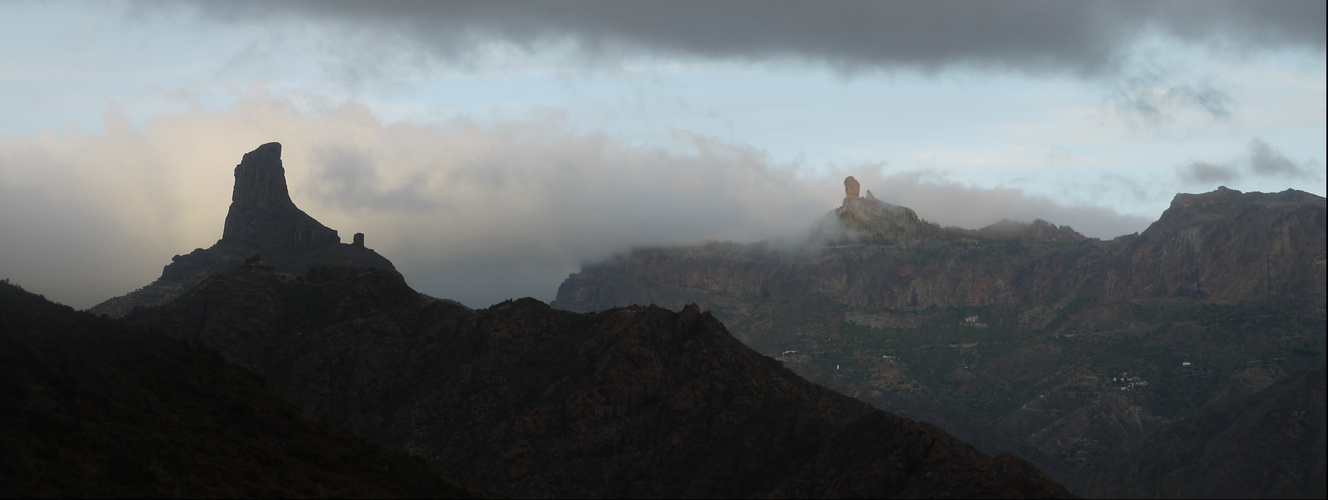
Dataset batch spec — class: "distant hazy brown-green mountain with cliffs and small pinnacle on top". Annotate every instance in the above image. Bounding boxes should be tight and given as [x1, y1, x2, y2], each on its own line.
[552, 179, 1328, 496]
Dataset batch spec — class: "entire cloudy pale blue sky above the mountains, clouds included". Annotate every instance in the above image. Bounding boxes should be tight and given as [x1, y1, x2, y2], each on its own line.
[0, 0, 1328, 308]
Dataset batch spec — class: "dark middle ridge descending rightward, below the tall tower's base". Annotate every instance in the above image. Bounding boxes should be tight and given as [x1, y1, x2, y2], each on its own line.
[126, 263, 1066, 497]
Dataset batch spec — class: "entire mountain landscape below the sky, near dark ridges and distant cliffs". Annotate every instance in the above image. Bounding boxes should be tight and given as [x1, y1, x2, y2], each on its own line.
[0, 143, 1328, 497]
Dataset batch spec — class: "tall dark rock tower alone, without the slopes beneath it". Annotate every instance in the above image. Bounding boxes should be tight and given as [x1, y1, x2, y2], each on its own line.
[222, 142, 341, 252]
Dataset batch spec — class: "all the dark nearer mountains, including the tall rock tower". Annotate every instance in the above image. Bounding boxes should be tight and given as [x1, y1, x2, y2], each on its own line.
[0, 143, 1069, 497]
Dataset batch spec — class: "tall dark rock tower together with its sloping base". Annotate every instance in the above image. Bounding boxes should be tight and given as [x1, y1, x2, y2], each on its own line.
[89, 142, 396, 317]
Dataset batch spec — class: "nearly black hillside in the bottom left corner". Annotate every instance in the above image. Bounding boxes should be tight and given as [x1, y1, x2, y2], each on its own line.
[0, 278, 478, 497]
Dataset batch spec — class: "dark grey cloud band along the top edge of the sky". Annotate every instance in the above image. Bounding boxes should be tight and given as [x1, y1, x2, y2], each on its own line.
[168, 0, 1325, 75]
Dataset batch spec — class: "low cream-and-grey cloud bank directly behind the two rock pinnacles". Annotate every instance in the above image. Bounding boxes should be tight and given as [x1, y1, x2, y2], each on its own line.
[0, 89, 1146, 308]
